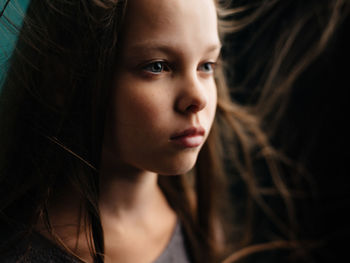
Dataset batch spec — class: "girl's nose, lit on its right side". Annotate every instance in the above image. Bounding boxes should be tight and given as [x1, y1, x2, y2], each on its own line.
[176, 72, 207, 114]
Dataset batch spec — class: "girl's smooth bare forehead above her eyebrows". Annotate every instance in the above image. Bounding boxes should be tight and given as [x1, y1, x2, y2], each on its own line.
[122, 0, 219, 51]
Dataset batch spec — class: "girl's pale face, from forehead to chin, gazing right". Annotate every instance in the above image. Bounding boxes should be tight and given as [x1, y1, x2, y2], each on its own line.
[103, 0, 220, 174]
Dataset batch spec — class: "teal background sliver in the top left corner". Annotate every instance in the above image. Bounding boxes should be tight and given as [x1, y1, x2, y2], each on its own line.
[0, 0, 30, 89]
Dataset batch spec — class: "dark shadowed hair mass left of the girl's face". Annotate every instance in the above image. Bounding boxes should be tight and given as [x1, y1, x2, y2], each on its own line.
[0, 0, 125, 262]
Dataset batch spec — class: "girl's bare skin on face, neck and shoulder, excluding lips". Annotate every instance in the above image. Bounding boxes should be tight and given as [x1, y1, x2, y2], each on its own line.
[39, 0, 221, 263]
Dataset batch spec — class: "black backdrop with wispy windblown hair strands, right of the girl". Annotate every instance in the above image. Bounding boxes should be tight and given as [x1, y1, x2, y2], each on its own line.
[219, 0, 350, 262]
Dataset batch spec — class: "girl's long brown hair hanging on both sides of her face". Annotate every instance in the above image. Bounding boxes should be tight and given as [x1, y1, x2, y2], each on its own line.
[0, 0, 267, 262]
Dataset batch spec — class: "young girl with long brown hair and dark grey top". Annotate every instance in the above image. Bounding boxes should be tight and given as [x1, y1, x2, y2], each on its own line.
[0, 0, 268, 262]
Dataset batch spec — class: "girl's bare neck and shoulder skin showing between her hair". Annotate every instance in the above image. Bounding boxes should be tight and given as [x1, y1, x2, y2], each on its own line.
[38, 162, 177, 262]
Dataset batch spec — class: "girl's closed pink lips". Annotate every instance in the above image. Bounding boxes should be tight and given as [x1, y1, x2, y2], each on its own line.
[170, 127, 205, 148]
